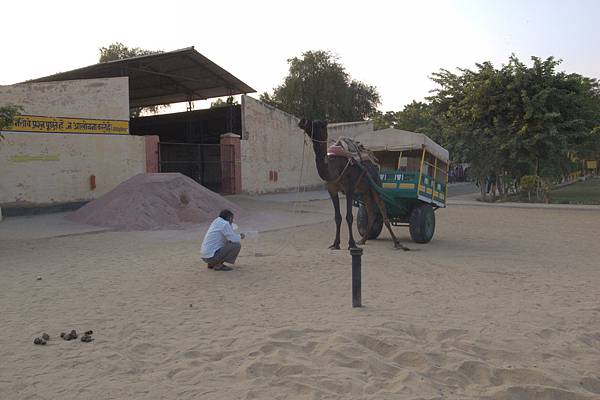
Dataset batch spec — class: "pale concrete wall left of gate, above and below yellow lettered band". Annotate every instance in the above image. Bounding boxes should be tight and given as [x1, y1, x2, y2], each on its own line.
[0, 77, 147, 206]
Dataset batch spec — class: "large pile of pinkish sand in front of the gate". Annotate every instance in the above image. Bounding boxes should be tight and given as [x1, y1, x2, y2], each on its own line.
[67, 173, 243, 230]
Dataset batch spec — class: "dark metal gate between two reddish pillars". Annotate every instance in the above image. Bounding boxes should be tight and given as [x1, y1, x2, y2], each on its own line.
[159, 143, 227, 193]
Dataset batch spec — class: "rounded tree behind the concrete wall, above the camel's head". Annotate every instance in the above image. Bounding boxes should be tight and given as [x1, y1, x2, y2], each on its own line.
[260, 50, 380, 122]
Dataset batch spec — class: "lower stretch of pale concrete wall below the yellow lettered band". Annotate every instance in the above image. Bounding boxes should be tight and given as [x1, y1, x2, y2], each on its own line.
[0, 132, 146, 207]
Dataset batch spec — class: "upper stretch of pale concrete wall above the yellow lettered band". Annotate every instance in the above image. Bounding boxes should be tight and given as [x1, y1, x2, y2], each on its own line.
[0, 77, 129, 121]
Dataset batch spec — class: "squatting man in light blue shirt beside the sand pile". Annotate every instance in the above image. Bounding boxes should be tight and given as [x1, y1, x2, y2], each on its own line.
[202, 210, 245, 271]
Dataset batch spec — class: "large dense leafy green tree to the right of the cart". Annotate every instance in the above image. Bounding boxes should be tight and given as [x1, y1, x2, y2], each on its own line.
[428, 56, 600, 199]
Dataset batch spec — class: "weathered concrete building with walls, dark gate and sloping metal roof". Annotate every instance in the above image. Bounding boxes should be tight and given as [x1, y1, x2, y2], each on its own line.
[0, 47, 372, 215]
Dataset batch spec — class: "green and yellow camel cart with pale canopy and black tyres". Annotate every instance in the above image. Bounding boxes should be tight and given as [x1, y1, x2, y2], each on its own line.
[353, 128, 449, 243]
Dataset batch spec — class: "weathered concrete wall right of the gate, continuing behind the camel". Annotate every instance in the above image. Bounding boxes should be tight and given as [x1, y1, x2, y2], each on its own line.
[241, 96, 373, 193]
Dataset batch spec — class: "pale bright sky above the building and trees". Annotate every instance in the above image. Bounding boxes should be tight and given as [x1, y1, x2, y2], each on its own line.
[0, 0, 600, 111]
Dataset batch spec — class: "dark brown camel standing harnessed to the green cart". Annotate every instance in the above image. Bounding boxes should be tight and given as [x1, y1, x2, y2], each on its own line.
[298, 118, 408, 250]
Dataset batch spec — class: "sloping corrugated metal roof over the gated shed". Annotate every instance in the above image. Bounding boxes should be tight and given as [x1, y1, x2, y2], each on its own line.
[28, 47, 256, 107]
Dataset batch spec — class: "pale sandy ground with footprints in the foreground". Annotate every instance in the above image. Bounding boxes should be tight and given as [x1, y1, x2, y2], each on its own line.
[0, 201, 600, 400]
